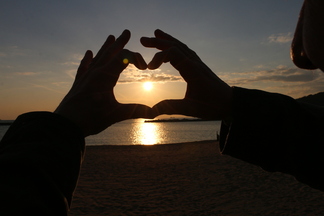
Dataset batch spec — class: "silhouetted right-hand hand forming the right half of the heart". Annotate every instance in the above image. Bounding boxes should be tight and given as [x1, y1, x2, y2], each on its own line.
[141, 30, 232, 120]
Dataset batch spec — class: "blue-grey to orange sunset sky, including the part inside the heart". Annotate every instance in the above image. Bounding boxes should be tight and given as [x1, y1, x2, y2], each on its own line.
[0, 0, 324, 120]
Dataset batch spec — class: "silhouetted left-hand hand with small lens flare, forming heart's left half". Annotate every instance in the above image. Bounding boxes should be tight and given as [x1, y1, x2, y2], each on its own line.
[55, 30, 155, 136]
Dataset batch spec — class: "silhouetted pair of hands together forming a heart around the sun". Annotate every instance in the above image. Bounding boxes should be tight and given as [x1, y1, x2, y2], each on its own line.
[55, 30, 232, 136]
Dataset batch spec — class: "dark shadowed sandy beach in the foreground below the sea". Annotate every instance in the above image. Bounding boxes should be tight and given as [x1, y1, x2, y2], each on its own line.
[69, 141, 324, 216]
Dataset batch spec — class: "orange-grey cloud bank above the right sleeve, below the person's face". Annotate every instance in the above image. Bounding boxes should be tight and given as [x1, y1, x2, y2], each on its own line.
[219, 65, 324, 98]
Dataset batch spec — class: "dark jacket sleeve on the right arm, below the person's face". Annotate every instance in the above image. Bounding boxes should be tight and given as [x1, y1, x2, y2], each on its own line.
[220, 87, 324, 191]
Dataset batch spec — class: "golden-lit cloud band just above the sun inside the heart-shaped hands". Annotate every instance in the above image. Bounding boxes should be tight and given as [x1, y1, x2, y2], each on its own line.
[118, 65, 183, 84]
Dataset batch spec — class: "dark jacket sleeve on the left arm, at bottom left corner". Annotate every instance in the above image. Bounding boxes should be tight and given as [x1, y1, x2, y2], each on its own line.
[0, 112, 85, 215]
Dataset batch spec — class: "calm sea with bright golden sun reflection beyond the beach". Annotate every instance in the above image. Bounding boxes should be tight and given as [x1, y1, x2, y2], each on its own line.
[0, 119, 221, 145]
